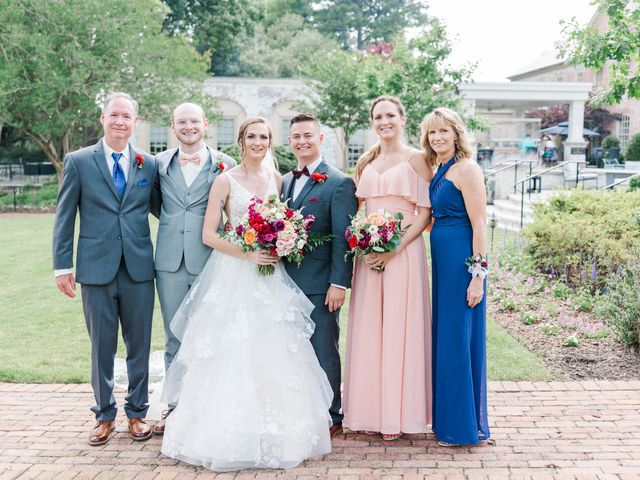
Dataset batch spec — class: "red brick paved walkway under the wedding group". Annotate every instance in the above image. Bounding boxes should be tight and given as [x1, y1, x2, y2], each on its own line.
[0, 381, 640, 480]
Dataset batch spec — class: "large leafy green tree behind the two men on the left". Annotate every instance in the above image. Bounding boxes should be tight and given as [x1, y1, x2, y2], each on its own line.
[0, 0, 207, 184]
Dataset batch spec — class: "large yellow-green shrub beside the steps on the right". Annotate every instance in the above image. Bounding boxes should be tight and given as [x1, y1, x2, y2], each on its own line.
[523, 190, 640, 288]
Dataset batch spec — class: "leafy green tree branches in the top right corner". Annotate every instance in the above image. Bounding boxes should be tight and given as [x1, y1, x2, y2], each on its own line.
[558, 0, 640, 105]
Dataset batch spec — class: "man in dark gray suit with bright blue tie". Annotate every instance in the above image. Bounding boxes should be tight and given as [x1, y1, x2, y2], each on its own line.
[53, 93, 157, 445]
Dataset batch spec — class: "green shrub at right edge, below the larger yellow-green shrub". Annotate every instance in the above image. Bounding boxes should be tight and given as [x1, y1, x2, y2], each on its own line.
[596, 255, 640, 349]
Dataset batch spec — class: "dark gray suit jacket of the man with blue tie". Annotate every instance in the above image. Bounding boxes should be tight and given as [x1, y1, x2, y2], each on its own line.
[53, 140, 157, 285]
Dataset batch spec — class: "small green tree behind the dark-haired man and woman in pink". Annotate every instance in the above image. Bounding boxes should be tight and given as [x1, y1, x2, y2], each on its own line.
[299, 50, 378, 161]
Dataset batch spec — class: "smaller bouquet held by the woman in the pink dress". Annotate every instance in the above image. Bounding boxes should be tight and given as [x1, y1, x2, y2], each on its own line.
[344, 210, 404, 272]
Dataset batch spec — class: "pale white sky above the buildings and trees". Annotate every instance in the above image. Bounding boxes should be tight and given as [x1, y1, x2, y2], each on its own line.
[425, 0, 596, 82]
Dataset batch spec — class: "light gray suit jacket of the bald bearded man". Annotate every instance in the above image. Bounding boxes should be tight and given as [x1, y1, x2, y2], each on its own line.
[152, 146, 236, 275]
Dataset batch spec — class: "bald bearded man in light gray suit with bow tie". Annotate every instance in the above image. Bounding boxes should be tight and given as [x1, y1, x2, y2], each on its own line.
[152, 103, 236, 435]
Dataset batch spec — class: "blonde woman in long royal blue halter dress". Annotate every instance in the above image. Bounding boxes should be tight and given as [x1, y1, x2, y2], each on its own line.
[421, 108, 489, 446]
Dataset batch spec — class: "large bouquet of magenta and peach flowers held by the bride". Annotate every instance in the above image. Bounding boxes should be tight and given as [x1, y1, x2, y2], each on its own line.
[220, 195, 331, 276]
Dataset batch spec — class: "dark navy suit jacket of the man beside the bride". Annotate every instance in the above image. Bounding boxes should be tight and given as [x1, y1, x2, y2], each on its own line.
[282, 161, 358, 295]
